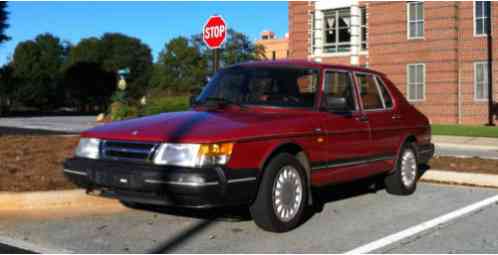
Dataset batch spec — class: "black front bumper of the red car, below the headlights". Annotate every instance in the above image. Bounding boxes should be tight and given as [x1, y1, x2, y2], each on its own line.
[64, 158, 258, 208]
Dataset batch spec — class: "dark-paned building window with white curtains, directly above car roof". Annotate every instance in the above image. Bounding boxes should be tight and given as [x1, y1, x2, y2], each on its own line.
[323, 8, 351, 53]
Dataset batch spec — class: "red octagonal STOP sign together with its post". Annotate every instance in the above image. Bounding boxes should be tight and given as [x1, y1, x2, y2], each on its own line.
[202, 15, 228, 72]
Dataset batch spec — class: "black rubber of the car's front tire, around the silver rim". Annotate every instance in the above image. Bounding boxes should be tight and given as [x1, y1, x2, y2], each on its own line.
[249, 153, 308, 233]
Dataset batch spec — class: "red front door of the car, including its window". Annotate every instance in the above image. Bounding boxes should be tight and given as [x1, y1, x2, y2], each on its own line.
[312, 70, 372, 185]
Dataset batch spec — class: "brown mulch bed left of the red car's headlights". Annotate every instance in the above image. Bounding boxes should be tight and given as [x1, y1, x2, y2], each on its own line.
[0, 132, 79, 192]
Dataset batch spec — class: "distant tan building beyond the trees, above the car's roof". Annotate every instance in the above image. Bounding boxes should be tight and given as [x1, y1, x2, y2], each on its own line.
[256, 31, 289, 60]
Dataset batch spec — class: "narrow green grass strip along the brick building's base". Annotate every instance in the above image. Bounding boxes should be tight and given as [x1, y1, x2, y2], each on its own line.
[432, 124, 498, 138]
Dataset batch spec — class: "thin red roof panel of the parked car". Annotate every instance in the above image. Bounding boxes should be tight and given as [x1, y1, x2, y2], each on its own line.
[230, 59, 384, 75]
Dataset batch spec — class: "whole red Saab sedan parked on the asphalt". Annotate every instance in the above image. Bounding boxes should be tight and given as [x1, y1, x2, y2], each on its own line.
[64, 61, 434, 232]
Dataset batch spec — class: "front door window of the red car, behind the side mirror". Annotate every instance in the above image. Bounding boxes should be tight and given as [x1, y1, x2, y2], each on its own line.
[322, 71, 356, 112]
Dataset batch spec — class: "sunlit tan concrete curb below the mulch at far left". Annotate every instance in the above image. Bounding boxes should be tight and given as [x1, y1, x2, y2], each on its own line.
[0, 189, 120, 212]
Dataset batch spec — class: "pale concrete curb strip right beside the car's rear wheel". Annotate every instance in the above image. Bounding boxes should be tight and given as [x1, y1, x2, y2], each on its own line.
[421, 169, 498, 188]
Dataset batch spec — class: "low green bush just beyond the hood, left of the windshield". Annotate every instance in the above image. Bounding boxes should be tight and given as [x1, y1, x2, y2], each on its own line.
[142, 96, 189, 115]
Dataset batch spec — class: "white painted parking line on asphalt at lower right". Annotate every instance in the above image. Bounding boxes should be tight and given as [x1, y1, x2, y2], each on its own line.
[346, 195, 498, 254]
